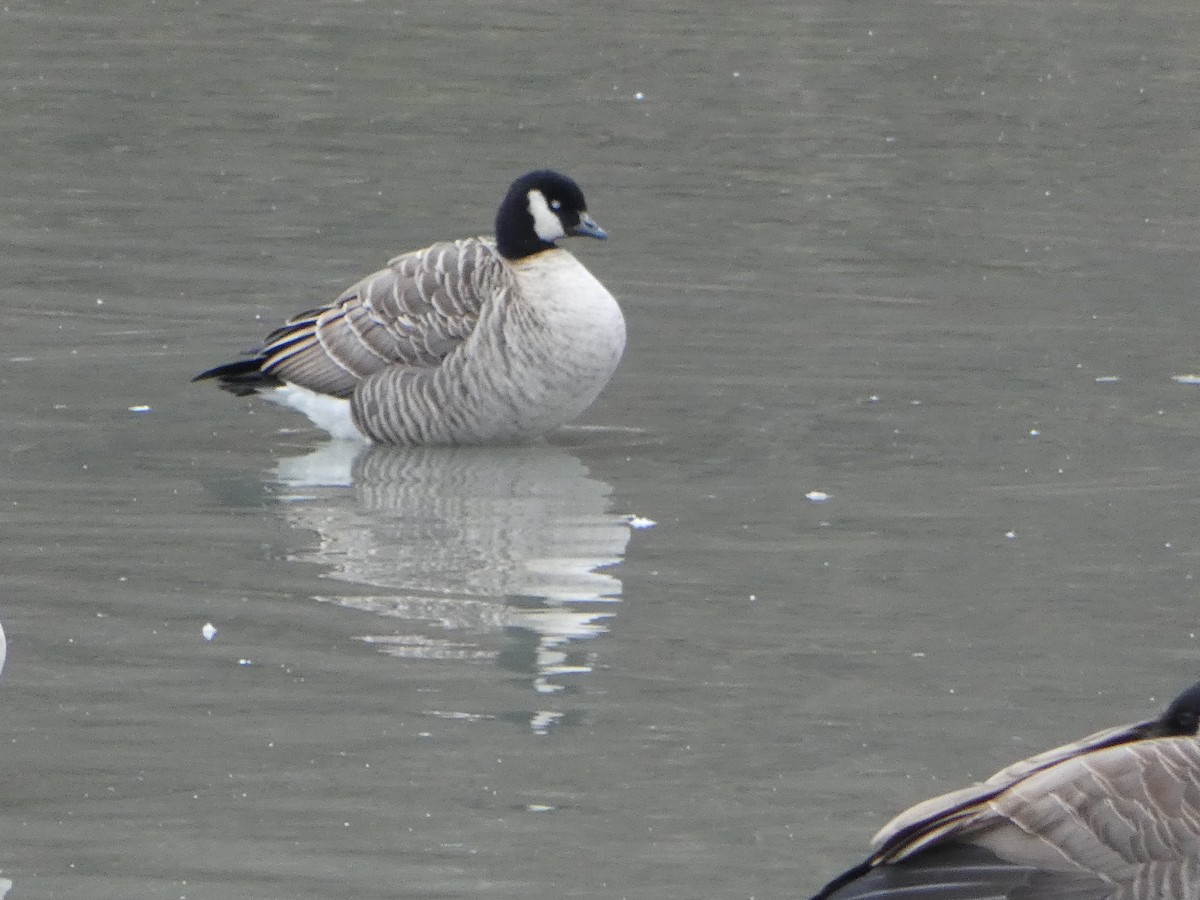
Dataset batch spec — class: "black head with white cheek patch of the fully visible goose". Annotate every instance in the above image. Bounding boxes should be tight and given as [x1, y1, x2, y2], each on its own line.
[496, 169, 608, 259]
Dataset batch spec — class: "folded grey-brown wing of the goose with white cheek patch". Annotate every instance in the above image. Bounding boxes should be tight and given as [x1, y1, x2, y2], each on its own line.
[260, 238, 511, 397]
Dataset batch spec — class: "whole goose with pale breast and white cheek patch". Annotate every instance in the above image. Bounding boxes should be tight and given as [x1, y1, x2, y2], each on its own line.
[194, 169, 625, 445]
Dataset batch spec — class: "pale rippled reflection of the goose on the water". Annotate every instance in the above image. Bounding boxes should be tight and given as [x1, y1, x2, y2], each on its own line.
[276, 443, 629, 730]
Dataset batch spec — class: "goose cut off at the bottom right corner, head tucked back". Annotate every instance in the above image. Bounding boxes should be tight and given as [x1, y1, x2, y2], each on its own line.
[814, 684, 1200, 900]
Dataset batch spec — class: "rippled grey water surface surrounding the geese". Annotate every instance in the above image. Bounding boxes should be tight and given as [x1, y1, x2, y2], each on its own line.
[0, 0, 1200, 900]
